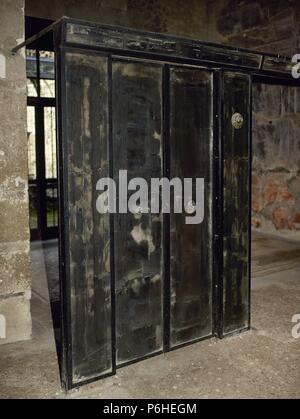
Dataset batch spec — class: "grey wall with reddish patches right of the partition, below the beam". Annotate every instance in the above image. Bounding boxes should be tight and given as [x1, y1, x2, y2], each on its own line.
[252, 84, 300, 237]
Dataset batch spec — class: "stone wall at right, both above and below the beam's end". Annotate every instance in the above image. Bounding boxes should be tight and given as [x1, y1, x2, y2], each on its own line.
[208, 0, 300, 239]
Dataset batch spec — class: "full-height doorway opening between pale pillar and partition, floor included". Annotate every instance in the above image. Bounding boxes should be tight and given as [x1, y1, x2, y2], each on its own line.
[25, 17, 60, 370]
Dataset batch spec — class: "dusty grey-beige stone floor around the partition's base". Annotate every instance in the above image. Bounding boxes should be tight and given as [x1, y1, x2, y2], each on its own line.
[0, 234, 300, 399]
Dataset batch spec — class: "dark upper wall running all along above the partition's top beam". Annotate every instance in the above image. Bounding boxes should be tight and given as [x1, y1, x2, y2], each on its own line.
[26, 0, 300, 54]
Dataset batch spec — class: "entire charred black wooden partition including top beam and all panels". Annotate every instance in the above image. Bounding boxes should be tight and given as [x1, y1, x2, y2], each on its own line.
[18, 18, 291, 388]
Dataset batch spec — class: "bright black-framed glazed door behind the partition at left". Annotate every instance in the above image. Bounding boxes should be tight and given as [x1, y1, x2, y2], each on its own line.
[26, 49, 58, 241]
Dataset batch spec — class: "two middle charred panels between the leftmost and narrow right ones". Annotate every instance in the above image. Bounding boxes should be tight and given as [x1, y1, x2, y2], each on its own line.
[112, 61, 213, 365]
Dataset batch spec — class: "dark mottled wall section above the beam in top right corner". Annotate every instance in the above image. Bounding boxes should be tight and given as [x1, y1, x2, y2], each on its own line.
[207, 0, 300, 55]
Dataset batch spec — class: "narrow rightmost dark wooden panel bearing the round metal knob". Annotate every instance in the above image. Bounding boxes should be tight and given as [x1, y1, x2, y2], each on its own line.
[223, 72, 251, 334]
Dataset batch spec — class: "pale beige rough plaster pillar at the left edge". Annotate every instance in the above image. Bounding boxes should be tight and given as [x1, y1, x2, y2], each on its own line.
[0, 0, 31, 345]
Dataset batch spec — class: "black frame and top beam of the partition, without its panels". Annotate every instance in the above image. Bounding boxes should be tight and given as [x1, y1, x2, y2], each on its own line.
[13, 17, 300, 389]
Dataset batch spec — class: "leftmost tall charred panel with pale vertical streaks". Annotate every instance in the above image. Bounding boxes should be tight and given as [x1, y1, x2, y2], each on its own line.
[62, 53, 112, 384]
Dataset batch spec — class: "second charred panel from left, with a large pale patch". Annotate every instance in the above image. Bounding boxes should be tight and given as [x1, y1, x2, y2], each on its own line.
[112, 61, 163, 364]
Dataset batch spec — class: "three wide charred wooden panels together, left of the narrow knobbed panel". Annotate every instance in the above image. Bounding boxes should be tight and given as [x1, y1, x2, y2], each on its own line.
[60, 52, 213, 386]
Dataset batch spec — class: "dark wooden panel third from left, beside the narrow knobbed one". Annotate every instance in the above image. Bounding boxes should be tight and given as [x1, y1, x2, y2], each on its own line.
[170, 68, 213, 347]
